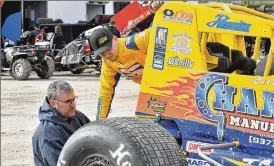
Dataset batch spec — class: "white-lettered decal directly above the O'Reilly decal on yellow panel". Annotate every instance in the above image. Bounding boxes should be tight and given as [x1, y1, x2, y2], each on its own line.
[170, 33, 192, 54]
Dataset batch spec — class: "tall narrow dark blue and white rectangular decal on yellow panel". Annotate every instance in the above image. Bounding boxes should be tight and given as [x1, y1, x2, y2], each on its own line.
[152, 27, 168, 70]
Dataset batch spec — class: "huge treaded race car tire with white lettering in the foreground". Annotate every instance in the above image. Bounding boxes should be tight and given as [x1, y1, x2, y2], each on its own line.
[57, 117, 188, 166]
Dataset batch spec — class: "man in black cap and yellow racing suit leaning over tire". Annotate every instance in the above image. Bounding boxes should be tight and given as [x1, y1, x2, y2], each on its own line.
[89, 1, 164, 120]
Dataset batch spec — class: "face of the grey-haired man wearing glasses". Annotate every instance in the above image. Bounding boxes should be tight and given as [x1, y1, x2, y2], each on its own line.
[50, 92, 77, 120]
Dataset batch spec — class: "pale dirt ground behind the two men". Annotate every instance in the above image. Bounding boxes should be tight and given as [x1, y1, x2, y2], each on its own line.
[1, 72, 140, 166]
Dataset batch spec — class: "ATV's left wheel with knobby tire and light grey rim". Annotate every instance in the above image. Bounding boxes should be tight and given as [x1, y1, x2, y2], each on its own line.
[11, 58, 31, 80]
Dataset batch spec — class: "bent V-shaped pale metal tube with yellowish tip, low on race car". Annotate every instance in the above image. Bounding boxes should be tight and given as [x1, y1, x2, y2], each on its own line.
[198, 141, 240, 166]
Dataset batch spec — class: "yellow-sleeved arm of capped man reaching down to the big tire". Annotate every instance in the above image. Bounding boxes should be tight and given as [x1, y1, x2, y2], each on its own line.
[96, 60, 121, 120]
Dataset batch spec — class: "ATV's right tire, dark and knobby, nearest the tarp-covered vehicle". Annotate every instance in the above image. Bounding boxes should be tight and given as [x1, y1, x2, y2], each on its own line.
[36, 56, 55, 79]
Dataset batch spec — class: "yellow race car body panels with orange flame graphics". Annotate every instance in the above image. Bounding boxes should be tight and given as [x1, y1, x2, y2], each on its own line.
[136, 2, 274, 137]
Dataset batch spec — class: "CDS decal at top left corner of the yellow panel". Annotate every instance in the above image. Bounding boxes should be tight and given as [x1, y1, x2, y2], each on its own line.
[163, 9, 194, 24]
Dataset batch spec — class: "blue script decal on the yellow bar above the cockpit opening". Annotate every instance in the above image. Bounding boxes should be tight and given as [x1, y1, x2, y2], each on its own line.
[206, 14, 251, 32]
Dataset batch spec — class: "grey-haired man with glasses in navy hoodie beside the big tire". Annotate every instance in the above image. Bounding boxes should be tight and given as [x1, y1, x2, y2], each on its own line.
[32, 80, 90, 166]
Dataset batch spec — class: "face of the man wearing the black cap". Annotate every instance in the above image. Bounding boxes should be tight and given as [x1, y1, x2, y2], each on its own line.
[100, 36, 118, 62]
